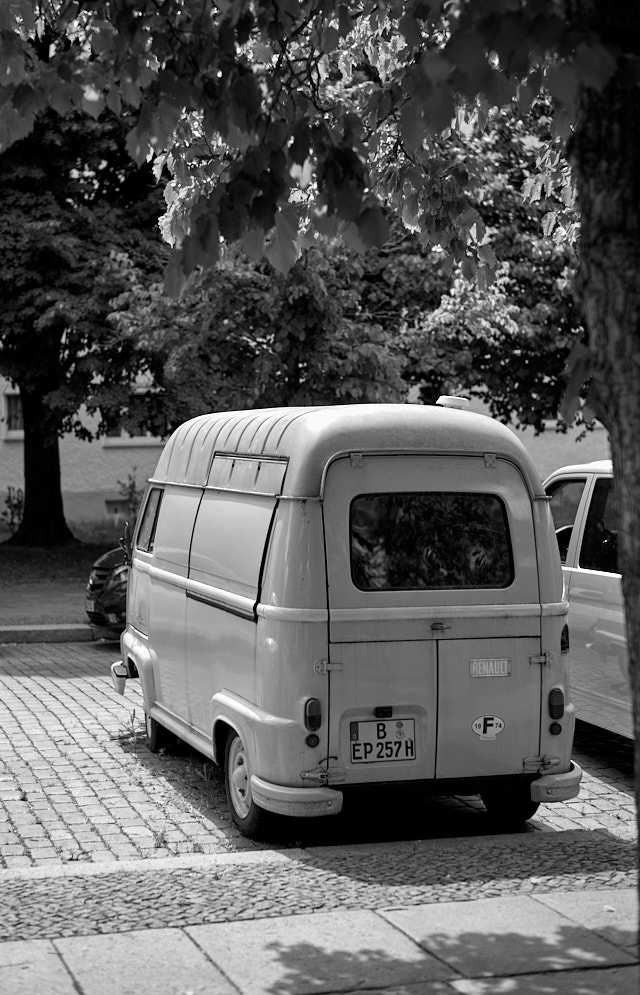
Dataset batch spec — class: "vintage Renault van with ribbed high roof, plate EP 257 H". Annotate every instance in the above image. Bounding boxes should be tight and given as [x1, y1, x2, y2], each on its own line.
[112, 399, 581, 836]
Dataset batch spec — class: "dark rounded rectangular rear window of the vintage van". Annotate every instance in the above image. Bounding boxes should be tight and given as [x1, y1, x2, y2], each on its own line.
[350, 492, 513, 591]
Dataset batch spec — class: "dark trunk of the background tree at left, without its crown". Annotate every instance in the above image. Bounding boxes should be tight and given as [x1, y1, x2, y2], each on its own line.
[9, 385, 75, 547]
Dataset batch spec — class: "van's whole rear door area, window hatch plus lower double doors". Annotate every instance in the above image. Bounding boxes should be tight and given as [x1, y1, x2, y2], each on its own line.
[323, 453, 541, 784]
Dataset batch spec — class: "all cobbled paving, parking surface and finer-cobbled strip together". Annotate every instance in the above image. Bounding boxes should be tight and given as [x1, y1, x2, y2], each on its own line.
[0, 643, 637, 941]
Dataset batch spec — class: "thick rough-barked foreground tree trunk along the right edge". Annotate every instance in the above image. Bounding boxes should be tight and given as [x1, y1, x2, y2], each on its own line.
[571, 0, 640, 860]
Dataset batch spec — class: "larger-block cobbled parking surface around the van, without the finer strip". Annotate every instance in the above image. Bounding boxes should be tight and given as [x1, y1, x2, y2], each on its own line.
[0, 643, 636, 869]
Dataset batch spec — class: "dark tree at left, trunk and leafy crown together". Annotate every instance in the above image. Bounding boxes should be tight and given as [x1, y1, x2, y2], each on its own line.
[0, 112, 164, 545]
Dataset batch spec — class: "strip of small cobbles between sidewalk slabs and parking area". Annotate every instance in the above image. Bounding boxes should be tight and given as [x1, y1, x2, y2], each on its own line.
[0, 830, 637, 942]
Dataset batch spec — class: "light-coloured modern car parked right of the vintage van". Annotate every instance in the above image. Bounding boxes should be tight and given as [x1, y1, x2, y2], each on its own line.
[544, 460, 633, 738]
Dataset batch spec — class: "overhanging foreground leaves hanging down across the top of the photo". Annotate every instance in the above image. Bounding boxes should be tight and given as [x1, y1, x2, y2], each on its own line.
[0, 0, 596, 289]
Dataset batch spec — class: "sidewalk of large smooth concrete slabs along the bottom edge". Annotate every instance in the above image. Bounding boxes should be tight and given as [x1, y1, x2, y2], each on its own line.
[0, 889, 639, 995]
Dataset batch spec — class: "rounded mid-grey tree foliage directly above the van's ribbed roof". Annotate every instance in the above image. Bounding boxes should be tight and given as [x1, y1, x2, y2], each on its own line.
[111, 245, 406, 429]
